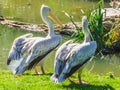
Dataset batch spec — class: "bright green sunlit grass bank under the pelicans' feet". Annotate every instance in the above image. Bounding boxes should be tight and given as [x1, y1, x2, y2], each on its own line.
[0, 70, 120, 90]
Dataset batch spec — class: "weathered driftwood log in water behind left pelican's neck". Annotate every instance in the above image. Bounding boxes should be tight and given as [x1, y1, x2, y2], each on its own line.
[0, 18, 81, 35]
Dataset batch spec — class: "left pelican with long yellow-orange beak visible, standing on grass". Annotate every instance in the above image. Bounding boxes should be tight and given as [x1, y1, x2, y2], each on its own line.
[7, 5, 63, 74]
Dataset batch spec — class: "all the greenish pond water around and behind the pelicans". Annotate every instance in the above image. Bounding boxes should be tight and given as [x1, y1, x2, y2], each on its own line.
[0, 0, 120, 77]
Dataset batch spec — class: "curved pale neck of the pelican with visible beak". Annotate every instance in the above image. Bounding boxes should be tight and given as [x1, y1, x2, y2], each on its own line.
[41, 13, 55, 37]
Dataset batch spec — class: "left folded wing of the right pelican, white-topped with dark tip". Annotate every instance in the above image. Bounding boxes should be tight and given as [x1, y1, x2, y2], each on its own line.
[54, 40, 74, 75]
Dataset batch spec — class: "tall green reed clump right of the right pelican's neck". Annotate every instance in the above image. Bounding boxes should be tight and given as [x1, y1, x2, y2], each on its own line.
[88, 0, 105, 52]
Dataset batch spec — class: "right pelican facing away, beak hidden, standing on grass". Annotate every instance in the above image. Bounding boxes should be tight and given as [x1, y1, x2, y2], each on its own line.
[50, 16, 97, 83]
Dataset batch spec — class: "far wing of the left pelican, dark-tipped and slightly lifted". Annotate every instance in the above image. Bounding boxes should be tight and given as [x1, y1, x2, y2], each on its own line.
[8, 33, 33, 64]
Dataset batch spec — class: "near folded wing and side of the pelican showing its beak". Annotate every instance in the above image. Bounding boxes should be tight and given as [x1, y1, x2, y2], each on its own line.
[9, 34, 61, 74]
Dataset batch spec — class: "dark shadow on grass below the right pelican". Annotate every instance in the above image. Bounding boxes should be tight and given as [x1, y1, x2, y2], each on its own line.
[63, 82, 115, 90]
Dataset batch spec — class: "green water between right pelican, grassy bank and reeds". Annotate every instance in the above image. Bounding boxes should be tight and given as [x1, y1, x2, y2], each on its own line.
[86, 54, 120, 77]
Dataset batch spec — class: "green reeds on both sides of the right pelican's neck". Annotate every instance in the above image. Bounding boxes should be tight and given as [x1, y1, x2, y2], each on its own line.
[65, 0, 106, 52]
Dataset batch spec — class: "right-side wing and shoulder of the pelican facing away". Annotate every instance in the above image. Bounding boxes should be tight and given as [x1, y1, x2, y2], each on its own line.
[63, 42, 97, 73]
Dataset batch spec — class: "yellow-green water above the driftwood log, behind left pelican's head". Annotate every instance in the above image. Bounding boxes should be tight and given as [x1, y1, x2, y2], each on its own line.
[0, 0, 109, 24]
